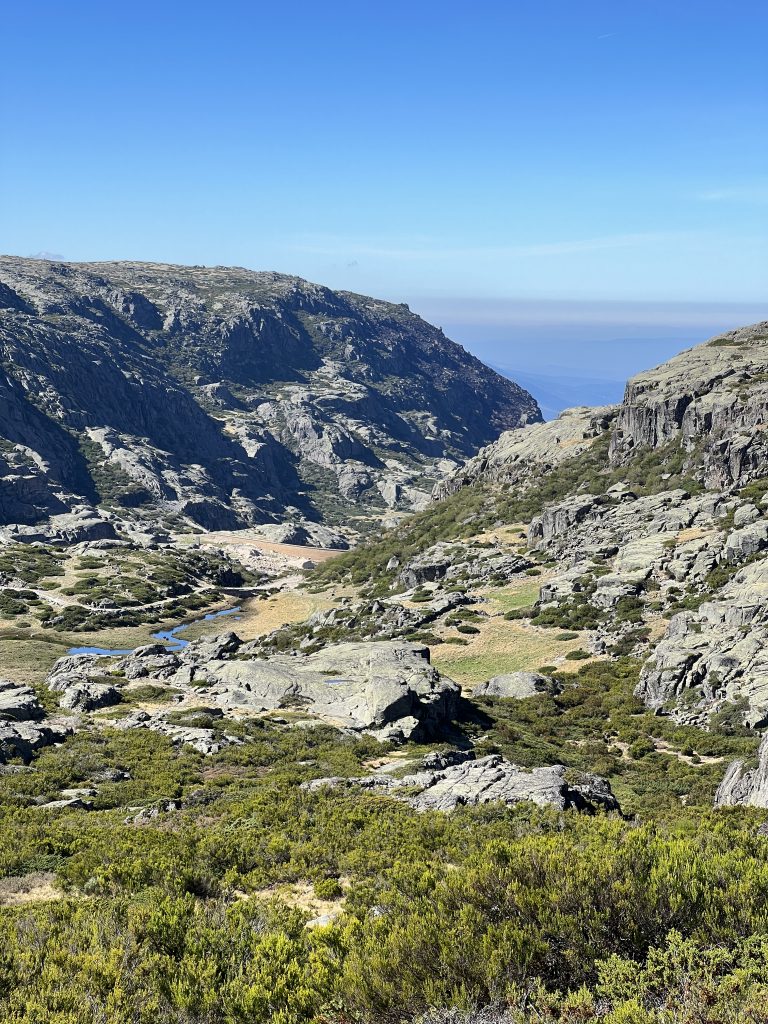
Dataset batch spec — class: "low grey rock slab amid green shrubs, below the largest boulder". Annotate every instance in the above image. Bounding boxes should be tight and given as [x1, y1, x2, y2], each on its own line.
[304, 754, 618, 811]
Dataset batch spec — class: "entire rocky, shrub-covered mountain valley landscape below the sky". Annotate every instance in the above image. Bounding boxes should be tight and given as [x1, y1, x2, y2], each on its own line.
[0, 257, 768, 1024]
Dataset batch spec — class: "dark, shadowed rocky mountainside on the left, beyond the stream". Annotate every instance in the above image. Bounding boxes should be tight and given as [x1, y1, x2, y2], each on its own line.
[0, 257, 541, 528]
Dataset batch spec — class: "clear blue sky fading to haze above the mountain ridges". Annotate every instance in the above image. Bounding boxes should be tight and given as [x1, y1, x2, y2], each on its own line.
[0, 0, 768, 407]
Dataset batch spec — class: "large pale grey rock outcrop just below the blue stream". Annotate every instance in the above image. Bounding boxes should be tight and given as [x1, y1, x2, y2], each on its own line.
[48, 633, 460, 753]
